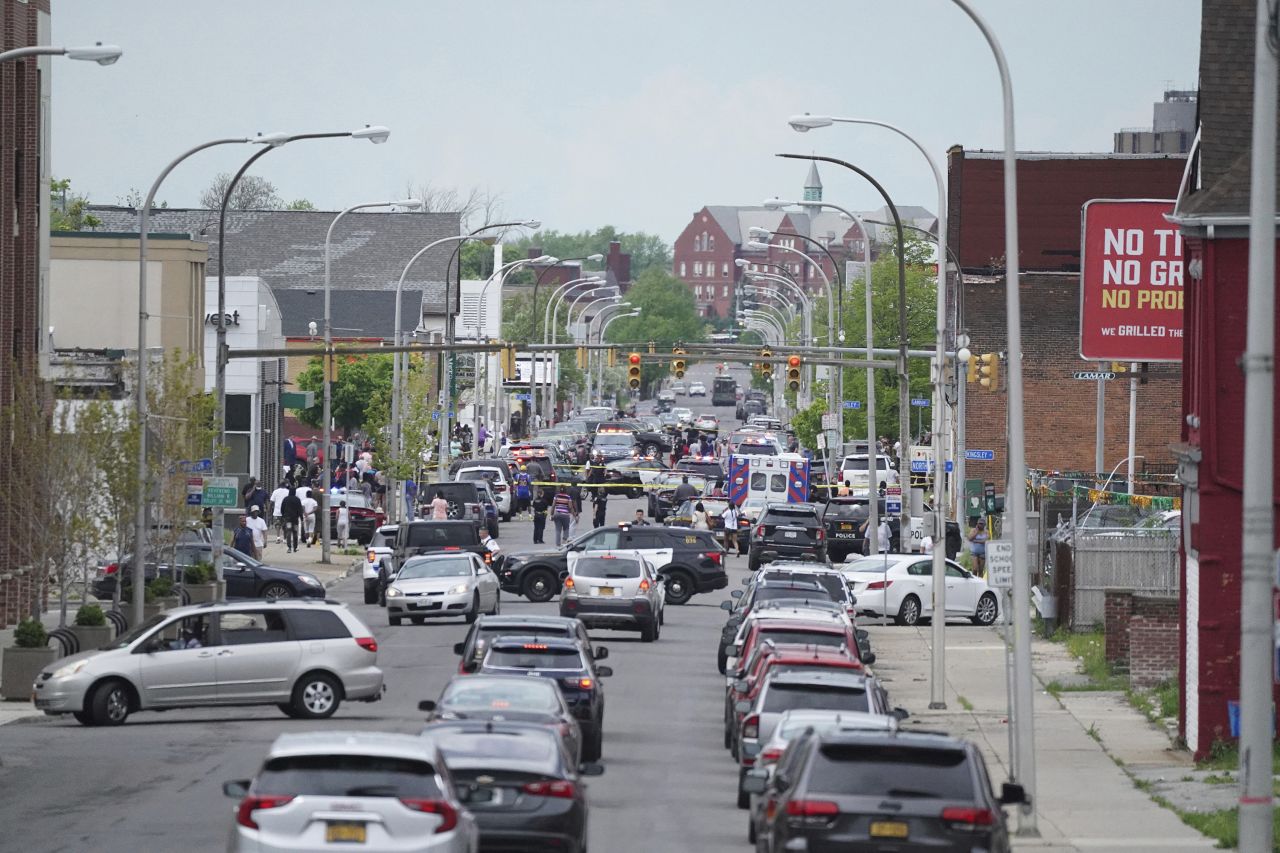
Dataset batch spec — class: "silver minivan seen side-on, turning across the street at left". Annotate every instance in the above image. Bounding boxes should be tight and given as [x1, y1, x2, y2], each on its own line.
[33, 599, 383, 726]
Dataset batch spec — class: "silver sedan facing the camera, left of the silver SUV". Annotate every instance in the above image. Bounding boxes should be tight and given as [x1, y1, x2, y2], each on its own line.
[387, 552, 502, 625]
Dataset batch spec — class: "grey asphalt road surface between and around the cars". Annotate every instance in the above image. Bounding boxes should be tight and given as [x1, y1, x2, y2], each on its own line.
[0, 368, 746, 853]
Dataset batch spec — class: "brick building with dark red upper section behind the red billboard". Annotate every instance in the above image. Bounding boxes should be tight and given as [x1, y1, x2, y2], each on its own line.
[947, 146, 1187, 491]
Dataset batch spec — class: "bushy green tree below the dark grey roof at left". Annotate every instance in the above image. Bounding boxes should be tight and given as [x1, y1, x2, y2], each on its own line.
[298, 350, 393, 434]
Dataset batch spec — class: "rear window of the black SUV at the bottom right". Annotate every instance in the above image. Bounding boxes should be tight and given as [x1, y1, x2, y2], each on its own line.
[805, 743, 975, 802]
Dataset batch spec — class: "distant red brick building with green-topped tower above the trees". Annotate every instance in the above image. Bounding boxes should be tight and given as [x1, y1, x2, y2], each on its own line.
[672, 164, 937, 319]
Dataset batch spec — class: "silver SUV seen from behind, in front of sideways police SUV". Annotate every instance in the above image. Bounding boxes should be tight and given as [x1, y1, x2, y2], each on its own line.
[561, 551, 667, 643]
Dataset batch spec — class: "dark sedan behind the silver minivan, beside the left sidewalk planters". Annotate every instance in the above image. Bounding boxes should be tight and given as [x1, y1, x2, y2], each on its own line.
[93, 543, 324, 601]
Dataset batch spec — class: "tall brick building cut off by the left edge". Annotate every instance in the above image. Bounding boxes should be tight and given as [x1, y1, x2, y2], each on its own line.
[0, 0, 50, 628]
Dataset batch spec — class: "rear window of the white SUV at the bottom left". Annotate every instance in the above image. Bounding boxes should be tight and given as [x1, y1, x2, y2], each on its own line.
[253, 753, 442, 799]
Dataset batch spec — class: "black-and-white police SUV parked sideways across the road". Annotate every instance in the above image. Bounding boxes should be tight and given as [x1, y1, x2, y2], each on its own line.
[498, 524, 728, 605]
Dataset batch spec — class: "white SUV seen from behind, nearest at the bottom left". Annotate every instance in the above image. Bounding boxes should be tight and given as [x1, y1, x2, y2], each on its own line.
[223, 731, 480, 853]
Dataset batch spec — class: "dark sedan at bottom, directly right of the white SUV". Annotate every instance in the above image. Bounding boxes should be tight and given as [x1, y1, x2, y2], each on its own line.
[422, 720, 604, 853]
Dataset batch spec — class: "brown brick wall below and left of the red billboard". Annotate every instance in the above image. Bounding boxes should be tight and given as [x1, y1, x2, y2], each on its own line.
[964, 274, 1181, 491]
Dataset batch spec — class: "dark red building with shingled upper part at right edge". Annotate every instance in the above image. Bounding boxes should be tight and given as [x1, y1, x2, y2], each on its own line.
[1172, 0, 1280, 757]
